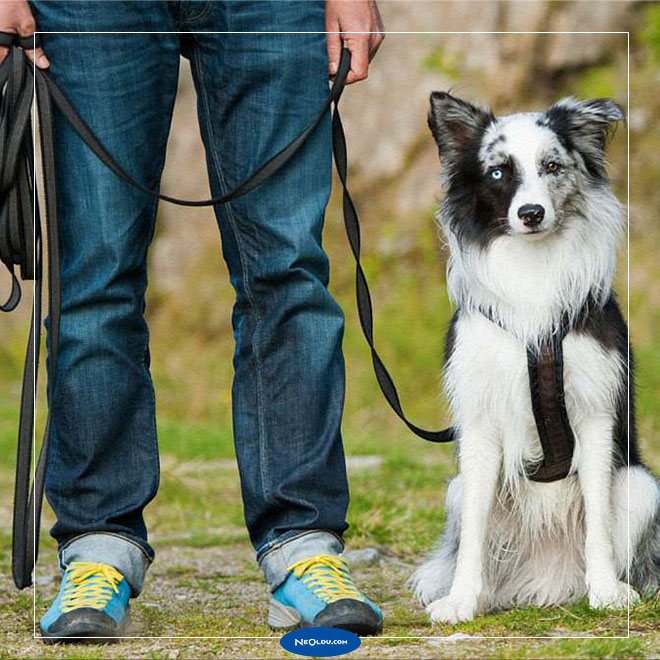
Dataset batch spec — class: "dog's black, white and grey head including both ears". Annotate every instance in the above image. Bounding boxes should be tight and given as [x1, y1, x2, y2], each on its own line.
[429, 92, 624, 250]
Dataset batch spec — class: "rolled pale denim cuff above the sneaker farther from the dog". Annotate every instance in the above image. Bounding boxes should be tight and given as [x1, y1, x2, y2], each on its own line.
[59, 532, 153, 598]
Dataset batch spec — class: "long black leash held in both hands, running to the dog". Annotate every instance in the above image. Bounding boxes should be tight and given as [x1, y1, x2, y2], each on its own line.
[0, 40, 454, 589]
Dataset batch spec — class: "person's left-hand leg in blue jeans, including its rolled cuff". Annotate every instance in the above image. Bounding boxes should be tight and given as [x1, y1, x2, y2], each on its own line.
[33, 1, 179, 595]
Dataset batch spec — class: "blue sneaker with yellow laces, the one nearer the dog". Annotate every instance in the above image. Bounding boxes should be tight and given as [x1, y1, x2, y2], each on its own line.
[268, 555, 383, 636]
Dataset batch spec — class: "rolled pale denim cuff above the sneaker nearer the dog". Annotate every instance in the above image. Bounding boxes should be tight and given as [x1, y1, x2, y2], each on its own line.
[257, 529, 344, 592]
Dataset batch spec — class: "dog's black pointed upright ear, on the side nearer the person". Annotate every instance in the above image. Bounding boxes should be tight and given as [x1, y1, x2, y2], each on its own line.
[428, 92, 494, 158]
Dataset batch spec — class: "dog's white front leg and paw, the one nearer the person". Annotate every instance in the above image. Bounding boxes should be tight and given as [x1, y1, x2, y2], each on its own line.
[426, 426, 502, 623]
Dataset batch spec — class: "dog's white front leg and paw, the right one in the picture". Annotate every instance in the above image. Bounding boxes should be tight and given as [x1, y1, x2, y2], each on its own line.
[578, 415, 638, 608]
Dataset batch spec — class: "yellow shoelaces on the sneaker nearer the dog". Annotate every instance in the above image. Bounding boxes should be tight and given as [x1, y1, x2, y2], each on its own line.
[288, 555, 364, 603]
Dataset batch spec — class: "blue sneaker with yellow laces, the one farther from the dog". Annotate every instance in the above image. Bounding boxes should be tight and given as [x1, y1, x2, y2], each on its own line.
[40, 562, 131, 644]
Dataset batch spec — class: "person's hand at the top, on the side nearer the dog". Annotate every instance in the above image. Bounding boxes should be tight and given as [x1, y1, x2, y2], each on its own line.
[325, 0, 385, 85]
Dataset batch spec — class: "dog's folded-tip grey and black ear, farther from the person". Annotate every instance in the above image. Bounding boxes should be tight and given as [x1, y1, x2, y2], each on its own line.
[546, 97, 626, 177]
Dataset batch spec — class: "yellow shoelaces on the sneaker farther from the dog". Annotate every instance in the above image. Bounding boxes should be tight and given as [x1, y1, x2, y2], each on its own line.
[62, 561, 124, 613]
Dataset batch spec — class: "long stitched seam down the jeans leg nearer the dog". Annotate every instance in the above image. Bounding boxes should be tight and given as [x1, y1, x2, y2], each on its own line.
[193, 46, 270, 498]
